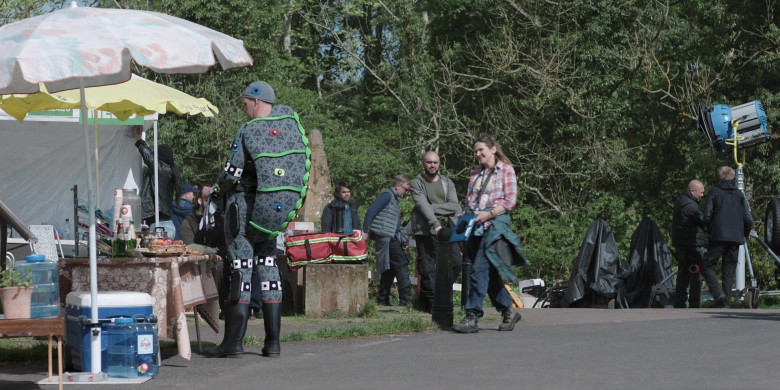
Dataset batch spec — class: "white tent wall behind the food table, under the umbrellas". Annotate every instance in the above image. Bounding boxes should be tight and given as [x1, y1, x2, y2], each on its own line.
[0, 110, 156, 239]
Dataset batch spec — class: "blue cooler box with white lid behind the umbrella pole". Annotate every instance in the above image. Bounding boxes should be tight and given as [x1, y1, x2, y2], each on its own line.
[65, 291, 156, 372]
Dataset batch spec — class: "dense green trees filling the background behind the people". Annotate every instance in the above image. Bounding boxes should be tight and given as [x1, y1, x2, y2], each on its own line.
[0, 0, 780, 289]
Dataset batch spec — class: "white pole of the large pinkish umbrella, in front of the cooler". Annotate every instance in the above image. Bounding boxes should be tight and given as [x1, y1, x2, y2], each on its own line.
[79, 82, 102, 374]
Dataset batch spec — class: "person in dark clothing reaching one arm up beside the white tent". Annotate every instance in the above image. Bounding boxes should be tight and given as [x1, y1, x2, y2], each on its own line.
[133, 126, 181, 237]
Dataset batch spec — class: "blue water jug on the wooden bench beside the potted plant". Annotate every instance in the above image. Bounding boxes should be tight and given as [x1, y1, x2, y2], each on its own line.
[14, 253, 60, 318]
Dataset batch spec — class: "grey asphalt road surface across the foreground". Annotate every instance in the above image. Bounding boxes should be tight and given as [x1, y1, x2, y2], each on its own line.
[0, 309, 780, 390]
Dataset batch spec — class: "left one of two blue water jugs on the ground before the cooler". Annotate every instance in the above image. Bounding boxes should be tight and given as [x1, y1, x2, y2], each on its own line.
[105, 317, 138, 378]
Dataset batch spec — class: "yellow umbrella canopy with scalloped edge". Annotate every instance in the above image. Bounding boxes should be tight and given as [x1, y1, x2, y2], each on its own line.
[0, 75, 219, 122]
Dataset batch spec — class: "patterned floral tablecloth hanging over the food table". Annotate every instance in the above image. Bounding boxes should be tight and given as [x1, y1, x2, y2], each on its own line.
[60, 255, 219, 360]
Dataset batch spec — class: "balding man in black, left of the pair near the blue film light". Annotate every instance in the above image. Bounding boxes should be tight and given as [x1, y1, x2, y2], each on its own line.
[672, 180, 706, 308]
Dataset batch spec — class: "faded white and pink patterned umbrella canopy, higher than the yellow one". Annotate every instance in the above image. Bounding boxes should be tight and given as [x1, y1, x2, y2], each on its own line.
[0, 2, 252, 94]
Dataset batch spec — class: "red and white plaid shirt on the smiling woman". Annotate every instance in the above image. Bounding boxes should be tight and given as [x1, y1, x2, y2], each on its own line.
[466, 161, 517, 213]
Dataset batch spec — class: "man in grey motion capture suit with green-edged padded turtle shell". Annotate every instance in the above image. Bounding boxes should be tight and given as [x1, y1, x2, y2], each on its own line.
[204, 81, 310, 357]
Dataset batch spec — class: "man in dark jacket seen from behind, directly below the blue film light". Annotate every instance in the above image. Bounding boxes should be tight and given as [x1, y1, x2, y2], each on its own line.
[702, 166, 753, 307]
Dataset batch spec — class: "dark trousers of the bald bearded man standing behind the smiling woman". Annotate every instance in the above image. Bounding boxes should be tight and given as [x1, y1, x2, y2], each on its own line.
[414, 235, 463, 311]
